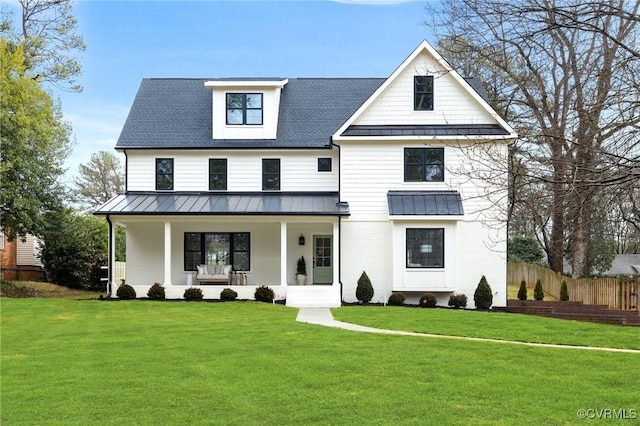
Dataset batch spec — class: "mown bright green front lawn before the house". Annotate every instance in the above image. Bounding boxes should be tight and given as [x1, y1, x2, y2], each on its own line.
[0, 299, 640, 425]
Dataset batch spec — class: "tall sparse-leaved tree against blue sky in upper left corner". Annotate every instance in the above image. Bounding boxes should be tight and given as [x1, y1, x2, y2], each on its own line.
[0, 0, 86, 92]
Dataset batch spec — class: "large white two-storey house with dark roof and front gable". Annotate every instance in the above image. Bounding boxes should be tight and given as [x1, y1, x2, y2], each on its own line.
[95, 42, 517, 306]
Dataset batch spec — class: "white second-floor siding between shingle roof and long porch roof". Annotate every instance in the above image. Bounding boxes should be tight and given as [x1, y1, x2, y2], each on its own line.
[127, 150, 338, 192]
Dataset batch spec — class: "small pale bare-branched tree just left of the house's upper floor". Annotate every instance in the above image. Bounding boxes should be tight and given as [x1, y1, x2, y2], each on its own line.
[75, 151, 124, 208]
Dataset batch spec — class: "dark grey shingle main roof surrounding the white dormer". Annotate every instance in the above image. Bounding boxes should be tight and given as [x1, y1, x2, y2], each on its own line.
[116, 78, 385, 148]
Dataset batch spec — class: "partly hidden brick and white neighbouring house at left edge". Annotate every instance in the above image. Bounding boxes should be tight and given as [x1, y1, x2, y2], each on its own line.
[0, 231, 45, 281]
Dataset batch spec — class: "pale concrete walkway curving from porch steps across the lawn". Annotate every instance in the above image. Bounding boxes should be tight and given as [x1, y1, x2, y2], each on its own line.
[296, 308, 640, 355]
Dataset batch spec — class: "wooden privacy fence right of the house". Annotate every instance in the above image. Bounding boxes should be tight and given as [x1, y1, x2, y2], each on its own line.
[507, 262, 640, 312]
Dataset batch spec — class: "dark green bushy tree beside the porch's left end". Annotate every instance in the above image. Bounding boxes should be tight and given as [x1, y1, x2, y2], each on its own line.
[41, 208, 108, 289]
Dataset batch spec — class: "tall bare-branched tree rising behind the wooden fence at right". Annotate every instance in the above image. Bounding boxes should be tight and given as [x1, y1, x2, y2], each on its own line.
[428, 0, 640, 276]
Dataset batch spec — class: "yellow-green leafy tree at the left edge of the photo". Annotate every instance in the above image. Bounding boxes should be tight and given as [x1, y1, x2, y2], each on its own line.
[0, 39, 70, 239]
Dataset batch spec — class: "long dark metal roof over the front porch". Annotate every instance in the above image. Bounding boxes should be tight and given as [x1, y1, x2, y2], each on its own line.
[94, 192, 349, 216]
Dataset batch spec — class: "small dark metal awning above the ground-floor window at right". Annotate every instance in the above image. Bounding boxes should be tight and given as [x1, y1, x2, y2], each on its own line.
[387, 191, 464, 216]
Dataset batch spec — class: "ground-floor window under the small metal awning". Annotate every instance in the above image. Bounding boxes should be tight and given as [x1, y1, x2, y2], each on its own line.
[407, 228, 444, 268]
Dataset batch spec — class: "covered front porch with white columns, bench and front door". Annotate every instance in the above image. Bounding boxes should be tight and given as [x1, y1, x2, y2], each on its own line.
[98, 195, 345, 306]
